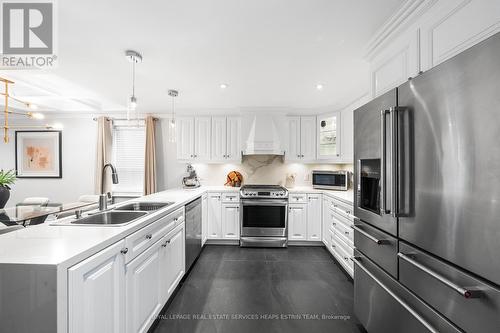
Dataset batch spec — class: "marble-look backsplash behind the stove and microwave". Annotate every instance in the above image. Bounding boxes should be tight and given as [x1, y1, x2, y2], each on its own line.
[193, 155, 353, 186]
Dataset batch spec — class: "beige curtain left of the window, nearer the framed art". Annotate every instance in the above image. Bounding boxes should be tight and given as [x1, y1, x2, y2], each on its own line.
[95, 117, 113, 194]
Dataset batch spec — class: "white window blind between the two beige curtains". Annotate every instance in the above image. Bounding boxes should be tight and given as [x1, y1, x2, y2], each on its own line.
[113, 125, 146, 195]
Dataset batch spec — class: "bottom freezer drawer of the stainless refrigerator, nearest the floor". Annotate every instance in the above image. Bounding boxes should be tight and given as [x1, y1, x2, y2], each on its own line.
[354, 251, 461, 333]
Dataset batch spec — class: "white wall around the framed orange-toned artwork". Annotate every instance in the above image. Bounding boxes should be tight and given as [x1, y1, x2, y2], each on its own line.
[0, 116, 97, 206]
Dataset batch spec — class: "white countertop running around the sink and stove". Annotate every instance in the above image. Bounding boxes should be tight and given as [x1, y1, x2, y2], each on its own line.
[0, 186, 353, 268]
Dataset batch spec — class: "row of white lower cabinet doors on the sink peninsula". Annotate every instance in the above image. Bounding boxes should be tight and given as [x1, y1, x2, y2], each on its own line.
[68, 222, 185, 333]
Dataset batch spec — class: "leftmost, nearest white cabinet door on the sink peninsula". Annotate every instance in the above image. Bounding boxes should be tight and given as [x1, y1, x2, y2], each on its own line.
[68, 240, 125, 333]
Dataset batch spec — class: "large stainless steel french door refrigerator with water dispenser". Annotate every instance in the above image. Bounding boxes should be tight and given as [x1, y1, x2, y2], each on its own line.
[353, 33, 500, 333]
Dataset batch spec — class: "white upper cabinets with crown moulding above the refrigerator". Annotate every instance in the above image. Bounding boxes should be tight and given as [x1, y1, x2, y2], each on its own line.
[366, 0, 500, 97]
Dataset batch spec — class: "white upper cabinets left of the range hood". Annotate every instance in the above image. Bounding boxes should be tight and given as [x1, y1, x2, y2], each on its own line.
[177, 116, 241, 162]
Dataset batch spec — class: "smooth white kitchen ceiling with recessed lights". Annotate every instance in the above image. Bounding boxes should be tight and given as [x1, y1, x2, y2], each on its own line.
[2, 0, 401, 113]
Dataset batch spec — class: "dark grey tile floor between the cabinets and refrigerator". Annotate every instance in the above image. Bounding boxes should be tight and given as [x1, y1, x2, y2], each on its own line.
[154, 246, 364, 333]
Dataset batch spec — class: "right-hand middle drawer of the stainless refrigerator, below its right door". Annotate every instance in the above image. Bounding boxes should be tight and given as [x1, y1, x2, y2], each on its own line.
[398, 242, 500, 332]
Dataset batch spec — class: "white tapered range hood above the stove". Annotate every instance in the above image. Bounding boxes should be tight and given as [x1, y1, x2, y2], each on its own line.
[243, 114, 285, 155]
